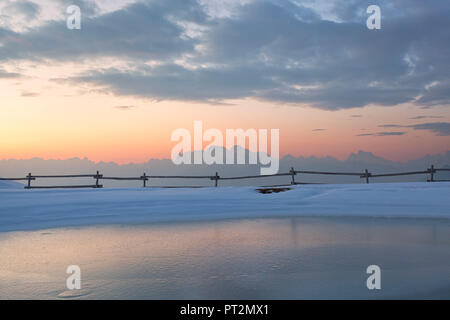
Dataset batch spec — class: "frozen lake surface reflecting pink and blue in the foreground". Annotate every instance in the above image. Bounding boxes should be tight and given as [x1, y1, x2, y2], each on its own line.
[0, 217, 450, 299]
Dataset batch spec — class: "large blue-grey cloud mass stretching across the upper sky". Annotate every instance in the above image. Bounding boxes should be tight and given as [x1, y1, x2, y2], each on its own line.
[0, 0, 450, 110]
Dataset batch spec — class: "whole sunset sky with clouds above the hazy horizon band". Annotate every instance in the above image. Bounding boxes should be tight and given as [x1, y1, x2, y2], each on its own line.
[0, 0, 450, 163]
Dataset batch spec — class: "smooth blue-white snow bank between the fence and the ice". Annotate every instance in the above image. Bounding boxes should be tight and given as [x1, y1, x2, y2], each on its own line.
[0, 183, 450, 231]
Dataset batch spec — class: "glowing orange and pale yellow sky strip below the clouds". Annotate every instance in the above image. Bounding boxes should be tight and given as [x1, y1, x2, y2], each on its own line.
[0, 75, 450, 164]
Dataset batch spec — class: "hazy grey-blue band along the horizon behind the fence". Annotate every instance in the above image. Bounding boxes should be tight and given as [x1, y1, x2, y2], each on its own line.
[0, 147, 450, 187]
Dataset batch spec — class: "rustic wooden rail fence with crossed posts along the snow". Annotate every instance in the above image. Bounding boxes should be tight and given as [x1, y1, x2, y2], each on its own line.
[0, 166, 450, 189]
